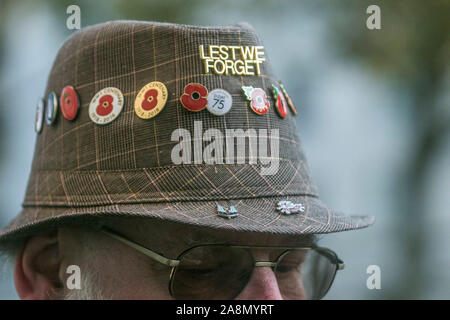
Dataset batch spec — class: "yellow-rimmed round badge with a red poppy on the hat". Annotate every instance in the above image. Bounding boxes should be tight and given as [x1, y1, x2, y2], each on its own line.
[134, 81, 167, 119]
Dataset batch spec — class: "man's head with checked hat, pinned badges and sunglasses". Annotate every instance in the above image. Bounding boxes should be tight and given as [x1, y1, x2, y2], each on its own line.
[0, 21, 374, 299]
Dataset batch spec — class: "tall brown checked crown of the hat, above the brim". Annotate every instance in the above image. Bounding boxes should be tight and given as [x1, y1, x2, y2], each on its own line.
[24, 21, 317, 206]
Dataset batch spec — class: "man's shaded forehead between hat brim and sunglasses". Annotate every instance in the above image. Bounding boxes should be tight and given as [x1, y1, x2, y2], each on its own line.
[100, 218, 314, 250]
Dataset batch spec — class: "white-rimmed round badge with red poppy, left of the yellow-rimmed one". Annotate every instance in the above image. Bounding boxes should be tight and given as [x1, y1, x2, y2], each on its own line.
[89, 87, 123, 124]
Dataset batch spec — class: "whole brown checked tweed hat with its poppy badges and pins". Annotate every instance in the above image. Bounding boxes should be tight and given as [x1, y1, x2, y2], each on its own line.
[0, 21, 374, 240]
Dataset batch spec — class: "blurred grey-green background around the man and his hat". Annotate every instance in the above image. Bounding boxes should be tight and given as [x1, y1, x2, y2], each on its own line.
[0, 0, 450, 299]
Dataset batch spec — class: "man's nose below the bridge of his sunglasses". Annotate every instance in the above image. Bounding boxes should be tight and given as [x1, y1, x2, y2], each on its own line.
[236, 267, 283, 300]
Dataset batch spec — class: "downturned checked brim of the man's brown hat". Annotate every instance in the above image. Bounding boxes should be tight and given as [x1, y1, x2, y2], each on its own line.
[0, 196, 375, 241]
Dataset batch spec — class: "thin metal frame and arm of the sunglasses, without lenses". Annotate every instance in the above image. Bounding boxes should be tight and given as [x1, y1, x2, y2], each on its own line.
[100, 227, 345, 298]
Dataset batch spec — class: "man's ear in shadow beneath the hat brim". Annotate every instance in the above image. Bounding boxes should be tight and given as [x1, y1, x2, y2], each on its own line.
[14, 230, 62, 300]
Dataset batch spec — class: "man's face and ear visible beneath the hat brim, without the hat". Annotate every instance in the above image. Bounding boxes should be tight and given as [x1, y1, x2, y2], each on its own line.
[10, 218, 320, 299]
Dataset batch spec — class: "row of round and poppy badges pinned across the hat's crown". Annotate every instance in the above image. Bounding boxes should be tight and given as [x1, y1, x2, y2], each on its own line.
[35, 81, 297, 133]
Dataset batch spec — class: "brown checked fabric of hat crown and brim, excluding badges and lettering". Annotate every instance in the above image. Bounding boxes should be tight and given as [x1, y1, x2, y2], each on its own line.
[0, 21, 373, 240]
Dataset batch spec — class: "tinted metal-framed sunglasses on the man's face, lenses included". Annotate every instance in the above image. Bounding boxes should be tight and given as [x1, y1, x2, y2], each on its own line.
[101, 227, 344, 300]
